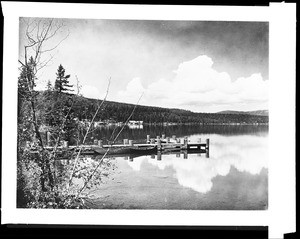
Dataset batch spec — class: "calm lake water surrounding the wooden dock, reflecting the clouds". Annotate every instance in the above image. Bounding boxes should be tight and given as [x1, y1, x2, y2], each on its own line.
[70, 126, 268, 210]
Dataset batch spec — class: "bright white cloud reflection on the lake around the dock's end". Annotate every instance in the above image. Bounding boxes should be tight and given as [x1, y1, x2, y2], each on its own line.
[123, 135, 268, 193]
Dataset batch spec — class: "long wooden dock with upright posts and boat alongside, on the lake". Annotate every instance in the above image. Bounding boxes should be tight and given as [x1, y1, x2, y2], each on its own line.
[45, 134, 209, 160]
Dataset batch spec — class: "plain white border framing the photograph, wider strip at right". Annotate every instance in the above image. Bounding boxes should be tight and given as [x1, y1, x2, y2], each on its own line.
[1, 2, 296, 238]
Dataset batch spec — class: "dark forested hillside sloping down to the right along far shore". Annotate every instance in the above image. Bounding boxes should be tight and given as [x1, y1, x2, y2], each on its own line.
[38, 91, 268, 124]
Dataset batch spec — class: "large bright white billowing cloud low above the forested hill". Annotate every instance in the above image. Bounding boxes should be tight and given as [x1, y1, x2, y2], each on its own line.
[119, 55, 268, 112]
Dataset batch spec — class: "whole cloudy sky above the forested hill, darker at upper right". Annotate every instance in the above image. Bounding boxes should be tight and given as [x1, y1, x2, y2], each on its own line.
[19, 18, 269, 112]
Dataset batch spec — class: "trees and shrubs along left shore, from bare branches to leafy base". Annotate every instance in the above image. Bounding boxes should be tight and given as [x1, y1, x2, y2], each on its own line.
[17, 19, 99, 208]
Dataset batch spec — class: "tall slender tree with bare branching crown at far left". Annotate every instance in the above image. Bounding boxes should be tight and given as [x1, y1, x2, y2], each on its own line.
[18, 19, 69, 194]
